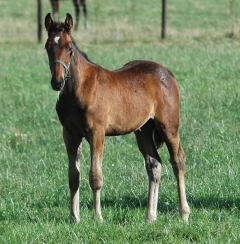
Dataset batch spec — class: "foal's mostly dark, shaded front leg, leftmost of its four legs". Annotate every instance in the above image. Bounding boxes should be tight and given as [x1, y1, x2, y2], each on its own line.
[63, 129, 82, 222]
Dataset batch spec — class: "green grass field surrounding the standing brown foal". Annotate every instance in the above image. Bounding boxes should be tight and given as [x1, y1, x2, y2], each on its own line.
[0, 0, 240, 244]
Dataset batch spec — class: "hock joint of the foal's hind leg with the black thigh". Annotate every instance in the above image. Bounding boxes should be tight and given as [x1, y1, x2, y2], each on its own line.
[146, 156, 161, 182]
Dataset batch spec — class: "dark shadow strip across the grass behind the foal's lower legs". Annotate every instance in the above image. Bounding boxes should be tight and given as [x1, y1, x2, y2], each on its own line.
[32, 194, 240, 213]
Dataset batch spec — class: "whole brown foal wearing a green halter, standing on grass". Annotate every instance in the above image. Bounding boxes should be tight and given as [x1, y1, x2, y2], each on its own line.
[45, 13, 190, 222]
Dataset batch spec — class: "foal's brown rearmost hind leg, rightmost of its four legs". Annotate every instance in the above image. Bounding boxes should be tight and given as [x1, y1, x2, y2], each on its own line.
[160, 128, 190, 221]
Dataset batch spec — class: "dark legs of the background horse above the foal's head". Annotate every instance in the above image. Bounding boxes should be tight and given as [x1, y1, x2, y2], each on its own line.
[50, 0, 87, 30]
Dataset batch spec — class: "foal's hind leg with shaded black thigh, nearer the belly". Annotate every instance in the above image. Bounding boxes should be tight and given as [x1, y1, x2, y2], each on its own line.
[135, 121, 162, 222]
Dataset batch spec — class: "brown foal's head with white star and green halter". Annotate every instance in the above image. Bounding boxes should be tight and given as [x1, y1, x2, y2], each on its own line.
[45, 13, 74, 91]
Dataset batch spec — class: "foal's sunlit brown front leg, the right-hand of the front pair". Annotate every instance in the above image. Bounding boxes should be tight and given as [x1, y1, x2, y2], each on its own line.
[89, 129, 105, 221]
